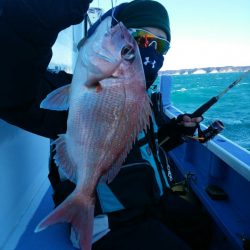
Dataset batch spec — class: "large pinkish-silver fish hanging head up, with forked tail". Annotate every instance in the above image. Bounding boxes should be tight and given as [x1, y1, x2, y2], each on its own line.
[36, 17, 151, 250]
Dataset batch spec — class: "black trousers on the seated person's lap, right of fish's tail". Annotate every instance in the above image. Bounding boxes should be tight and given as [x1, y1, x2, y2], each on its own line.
[93, 191, 212, 250]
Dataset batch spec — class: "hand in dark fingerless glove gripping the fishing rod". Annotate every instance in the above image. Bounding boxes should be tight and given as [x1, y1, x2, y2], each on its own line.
[176, 114, 203, 136]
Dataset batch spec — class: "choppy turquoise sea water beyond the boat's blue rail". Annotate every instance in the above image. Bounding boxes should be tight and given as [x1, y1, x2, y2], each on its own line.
[159, 72, 250, 150]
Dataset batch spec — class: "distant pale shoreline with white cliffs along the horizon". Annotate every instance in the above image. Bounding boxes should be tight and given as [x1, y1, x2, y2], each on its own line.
[160, 66, 250, 75]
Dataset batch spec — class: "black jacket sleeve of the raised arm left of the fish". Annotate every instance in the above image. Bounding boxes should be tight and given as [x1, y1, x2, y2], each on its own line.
[0, 0, 90, 137]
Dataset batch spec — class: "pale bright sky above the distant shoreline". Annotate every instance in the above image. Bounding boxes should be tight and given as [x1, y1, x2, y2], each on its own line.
[91, 0, 250, 70]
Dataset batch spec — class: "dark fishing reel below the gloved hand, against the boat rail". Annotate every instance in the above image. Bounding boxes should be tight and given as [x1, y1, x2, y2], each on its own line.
[197, 120, 224, 143]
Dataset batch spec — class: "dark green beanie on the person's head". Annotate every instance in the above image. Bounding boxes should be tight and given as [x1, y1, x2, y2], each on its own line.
[116, 0, 171, 42]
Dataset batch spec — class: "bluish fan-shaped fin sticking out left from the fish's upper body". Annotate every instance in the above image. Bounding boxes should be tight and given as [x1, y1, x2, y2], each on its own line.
[40, 84, 70, 111]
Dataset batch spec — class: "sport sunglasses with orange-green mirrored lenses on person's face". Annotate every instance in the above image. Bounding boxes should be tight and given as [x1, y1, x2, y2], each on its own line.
[129, 29, 170, 55]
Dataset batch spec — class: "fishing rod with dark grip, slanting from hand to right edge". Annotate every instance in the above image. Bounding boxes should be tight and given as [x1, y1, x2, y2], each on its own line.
[189, 70, 250, 118]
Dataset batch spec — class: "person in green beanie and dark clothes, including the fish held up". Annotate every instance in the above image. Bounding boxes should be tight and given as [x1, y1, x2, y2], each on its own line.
[0, 0, 207, 250]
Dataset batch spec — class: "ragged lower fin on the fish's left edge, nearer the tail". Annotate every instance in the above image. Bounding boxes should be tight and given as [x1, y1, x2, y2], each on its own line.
[53, 135, 77, 183]
